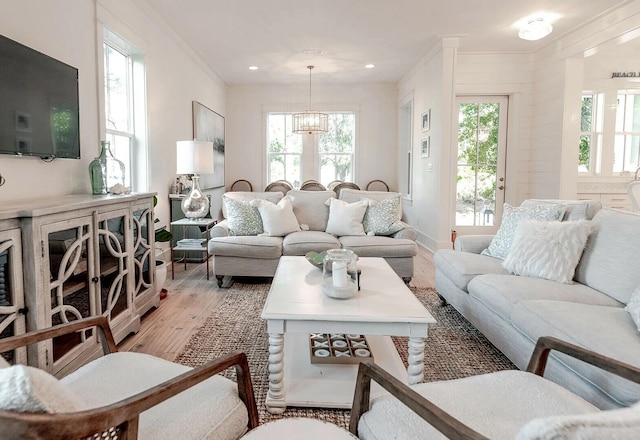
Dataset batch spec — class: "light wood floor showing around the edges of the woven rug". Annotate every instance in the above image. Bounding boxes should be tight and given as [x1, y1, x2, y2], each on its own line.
[118, 248, 435, 361]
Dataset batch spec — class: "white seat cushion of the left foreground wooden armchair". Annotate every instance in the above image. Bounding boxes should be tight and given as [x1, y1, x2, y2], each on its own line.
[61, 352, 248, 440]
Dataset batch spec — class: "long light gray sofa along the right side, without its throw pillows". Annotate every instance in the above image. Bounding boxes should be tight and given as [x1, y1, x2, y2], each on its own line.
[434, 201, 640, 409]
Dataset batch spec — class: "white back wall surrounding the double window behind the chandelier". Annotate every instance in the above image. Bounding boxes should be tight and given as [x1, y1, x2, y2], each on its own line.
[225, 83, 398, 197]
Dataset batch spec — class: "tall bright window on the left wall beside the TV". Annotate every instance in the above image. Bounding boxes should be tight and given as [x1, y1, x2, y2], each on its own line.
[103, 30, 147, 191]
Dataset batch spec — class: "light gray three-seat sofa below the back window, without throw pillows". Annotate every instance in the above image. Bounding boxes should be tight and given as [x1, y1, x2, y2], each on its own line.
[208, 189, 418, 286]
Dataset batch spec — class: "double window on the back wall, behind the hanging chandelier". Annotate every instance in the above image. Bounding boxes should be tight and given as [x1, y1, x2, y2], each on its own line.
[267, 112, 356, 187]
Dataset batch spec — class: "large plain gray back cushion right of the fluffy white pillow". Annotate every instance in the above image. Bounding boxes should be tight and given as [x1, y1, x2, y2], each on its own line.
[575, 209, 640, 304]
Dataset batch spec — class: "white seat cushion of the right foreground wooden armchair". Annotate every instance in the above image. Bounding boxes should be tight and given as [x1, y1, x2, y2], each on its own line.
[358, 370, 598, 440]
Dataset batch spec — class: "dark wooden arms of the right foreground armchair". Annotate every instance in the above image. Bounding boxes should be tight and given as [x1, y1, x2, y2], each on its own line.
[349, 336, 640, 440]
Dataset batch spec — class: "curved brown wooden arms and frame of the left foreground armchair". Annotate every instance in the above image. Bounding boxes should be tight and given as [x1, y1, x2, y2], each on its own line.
[0, 316, 259, 440]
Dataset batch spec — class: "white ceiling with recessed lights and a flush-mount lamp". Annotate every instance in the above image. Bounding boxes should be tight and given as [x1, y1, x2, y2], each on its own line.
[146, 0, 631, 84]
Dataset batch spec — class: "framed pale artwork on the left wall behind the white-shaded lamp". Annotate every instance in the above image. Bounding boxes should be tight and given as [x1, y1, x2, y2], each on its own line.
[193, 101, 224, 189]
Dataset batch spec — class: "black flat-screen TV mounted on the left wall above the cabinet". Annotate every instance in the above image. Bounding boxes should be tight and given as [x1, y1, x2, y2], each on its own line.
[0, 35, 80, 159]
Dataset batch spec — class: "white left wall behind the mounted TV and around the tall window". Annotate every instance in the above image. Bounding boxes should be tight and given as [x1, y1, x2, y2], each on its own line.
[0, 0, 225, 230]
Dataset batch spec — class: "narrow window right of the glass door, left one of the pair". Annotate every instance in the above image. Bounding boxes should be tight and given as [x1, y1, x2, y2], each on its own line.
[578, 93, 604, 173]
